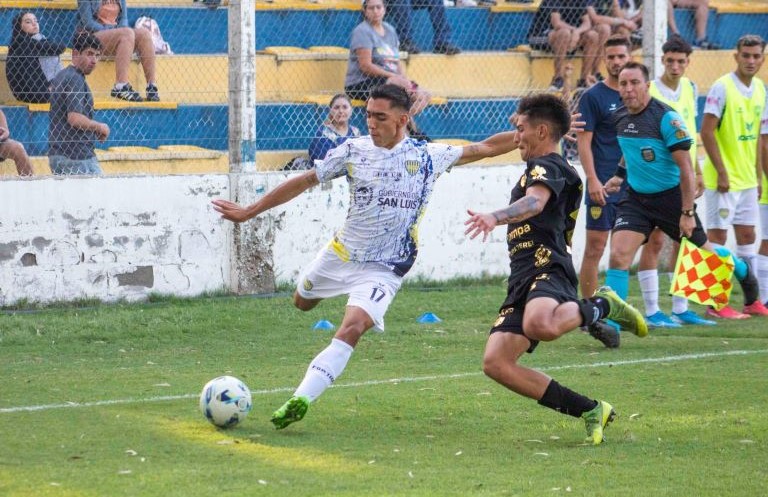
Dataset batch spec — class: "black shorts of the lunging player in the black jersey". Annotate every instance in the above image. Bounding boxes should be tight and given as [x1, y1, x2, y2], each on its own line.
[490, 266, 578, 354]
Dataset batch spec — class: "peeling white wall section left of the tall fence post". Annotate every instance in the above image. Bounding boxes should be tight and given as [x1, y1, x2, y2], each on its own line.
[0, 175, 231, 305]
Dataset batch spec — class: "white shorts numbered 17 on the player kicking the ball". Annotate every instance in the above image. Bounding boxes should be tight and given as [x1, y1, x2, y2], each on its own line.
[296, 249, 403, 331]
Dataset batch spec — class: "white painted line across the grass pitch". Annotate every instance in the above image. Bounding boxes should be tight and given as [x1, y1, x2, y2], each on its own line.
[0, 349, 768, 414]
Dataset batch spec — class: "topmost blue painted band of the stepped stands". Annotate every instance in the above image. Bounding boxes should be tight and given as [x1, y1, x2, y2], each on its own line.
[0, 6, 768, 54]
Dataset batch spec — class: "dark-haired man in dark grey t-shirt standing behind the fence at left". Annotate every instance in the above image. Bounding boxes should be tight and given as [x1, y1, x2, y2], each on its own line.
[48, 31, 109, 174]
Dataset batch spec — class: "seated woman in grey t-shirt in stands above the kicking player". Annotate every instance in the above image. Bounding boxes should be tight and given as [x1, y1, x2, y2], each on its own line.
[344, 0, 430, 116]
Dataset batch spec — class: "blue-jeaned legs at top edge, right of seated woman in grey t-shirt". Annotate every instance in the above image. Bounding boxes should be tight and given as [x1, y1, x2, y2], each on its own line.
[386, 0, 462, 55]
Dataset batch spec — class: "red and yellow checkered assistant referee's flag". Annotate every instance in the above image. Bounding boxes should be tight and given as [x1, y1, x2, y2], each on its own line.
[669, 238, 734, 311]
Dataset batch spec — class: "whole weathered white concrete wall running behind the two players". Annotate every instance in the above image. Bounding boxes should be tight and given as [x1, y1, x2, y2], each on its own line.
[0, 166, 608, 305]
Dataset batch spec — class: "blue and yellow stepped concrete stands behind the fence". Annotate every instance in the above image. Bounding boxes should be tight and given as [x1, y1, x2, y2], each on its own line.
[0, 0, 768, 175]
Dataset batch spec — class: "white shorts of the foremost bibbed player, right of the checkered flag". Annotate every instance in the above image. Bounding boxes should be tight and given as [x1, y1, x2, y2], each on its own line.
[704, 188, 758, 230]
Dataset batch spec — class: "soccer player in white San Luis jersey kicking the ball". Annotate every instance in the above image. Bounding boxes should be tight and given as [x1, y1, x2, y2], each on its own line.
[213, 84, 540, 429]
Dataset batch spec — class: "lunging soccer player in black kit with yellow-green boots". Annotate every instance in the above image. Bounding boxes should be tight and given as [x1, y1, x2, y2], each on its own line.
[465, 94, 648, 445]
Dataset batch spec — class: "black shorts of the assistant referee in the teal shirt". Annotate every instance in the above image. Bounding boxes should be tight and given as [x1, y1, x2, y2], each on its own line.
[613, 187, 707, 247]
